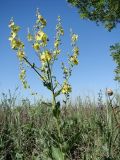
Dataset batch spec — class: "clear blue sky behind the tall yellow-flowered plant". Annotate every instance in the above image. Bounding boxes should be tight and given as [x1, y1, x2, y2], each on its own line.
[0, 0, 120, 97]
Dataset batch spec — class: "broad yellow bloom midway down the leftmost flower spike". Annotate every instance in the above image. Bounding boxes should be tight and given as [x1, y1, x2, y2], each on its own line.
[11, 39, 24, 50]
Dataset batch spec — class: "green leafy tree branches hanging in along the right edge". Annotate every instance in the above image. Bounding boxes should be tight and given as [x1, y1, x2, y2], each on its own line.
[67, 0, 120, 82]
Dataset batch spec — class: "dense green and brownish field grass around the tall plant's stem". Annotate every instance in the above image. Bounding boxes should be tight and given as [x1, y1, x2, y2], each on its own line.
[0, 89, 120, 160]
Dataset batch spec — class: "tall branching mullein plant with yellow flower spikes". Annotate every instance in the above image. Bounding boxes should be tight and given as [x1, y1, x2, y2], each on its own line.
[9, 10, 79, 160]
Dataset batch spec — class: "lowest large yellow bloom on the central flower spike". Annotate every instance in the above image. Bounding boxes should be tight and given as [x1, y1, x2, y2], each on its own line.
[40, 50, 52, 63]
